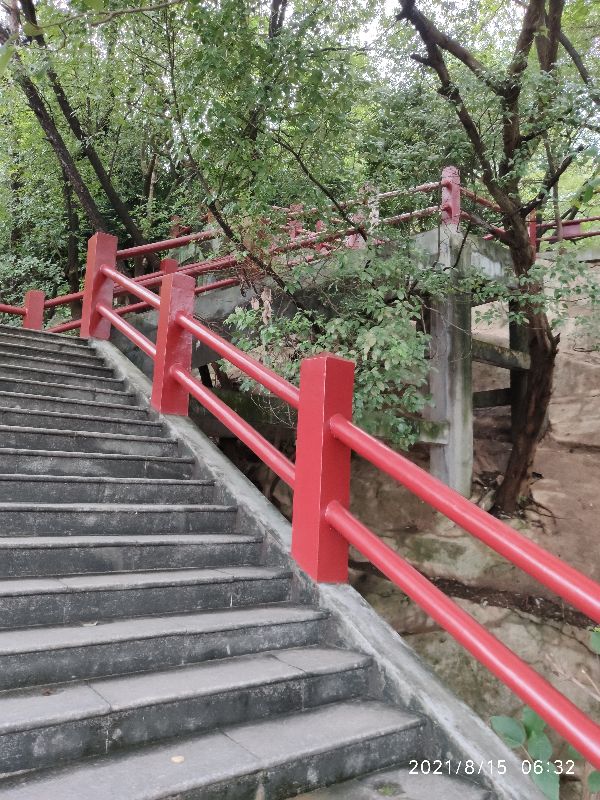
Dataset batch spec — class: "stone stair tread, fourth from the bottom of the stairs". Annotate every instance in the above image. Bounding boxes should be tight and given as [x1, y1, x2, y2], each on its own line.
[0, 603, 327, 657]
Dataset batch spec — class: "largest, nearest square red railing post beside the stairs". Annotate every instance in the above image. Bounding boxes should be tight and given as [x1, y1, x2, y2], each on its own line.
[292, 353, 354, 583]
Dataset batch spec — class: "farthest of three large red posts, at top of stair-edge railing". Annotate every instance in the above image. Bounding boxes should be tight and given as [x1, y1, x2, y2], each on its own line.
[79, 233, 118, 339]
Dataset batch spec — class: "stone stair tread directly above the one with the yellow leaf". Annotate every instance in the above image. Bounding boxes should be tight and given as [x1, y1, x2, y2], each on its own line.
[0, 647, 371, 735]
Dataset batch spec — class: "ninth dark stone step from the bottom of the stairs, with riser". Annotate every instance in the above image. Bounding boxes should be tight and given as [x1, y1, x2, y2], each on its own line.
[0, 447, 195, 479]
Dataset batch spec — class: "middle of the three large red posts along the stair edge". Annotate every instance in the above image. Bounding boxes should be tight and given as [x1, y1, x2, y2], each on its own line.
[151, 272, 196, 417]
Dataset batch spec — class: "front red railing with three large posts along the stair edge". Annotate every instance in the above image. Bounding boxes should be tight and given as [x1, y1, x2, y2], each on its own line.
[74, 227, 600, 767]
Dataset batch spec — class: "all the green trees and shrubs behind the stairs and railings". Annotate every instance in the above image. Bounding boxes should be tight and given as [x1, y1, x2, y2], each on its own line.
[0, 0, 600, 512]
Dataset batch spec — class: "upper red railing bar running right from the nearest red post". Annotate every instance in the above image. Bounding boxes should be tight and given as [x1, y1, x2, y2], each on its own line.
[330, 414, 600, 622]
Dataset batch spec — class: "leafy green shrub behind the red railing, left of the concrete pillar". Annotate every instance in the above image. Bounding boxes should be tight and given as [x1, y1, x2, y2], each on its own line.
[228, 241, 445, 446]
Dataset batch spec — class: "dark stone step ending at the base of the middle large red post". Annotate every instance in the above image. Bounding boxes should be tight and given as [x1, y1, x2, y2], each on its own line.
[0, 386, 151, 420]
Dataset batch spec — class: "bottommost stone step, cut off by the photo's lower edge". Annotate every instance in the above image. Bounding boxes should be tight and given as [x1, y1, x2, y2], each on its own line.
[298, 759, 494, 800]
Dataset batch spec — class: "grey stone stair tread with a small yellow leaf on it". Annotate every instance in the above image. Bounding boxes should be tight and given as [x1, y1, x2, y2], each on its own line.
[0, 701, 421, 800]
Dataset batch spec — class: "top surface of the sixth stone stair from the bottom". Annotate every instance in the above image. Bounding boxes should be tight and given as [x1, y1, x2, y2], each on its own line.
[0, 531, 262, 551]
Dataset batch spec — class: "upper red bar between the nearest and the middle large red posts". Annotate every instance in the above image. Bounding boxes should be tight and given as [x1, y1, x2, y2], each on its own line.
[176, 314, 300, 408]
